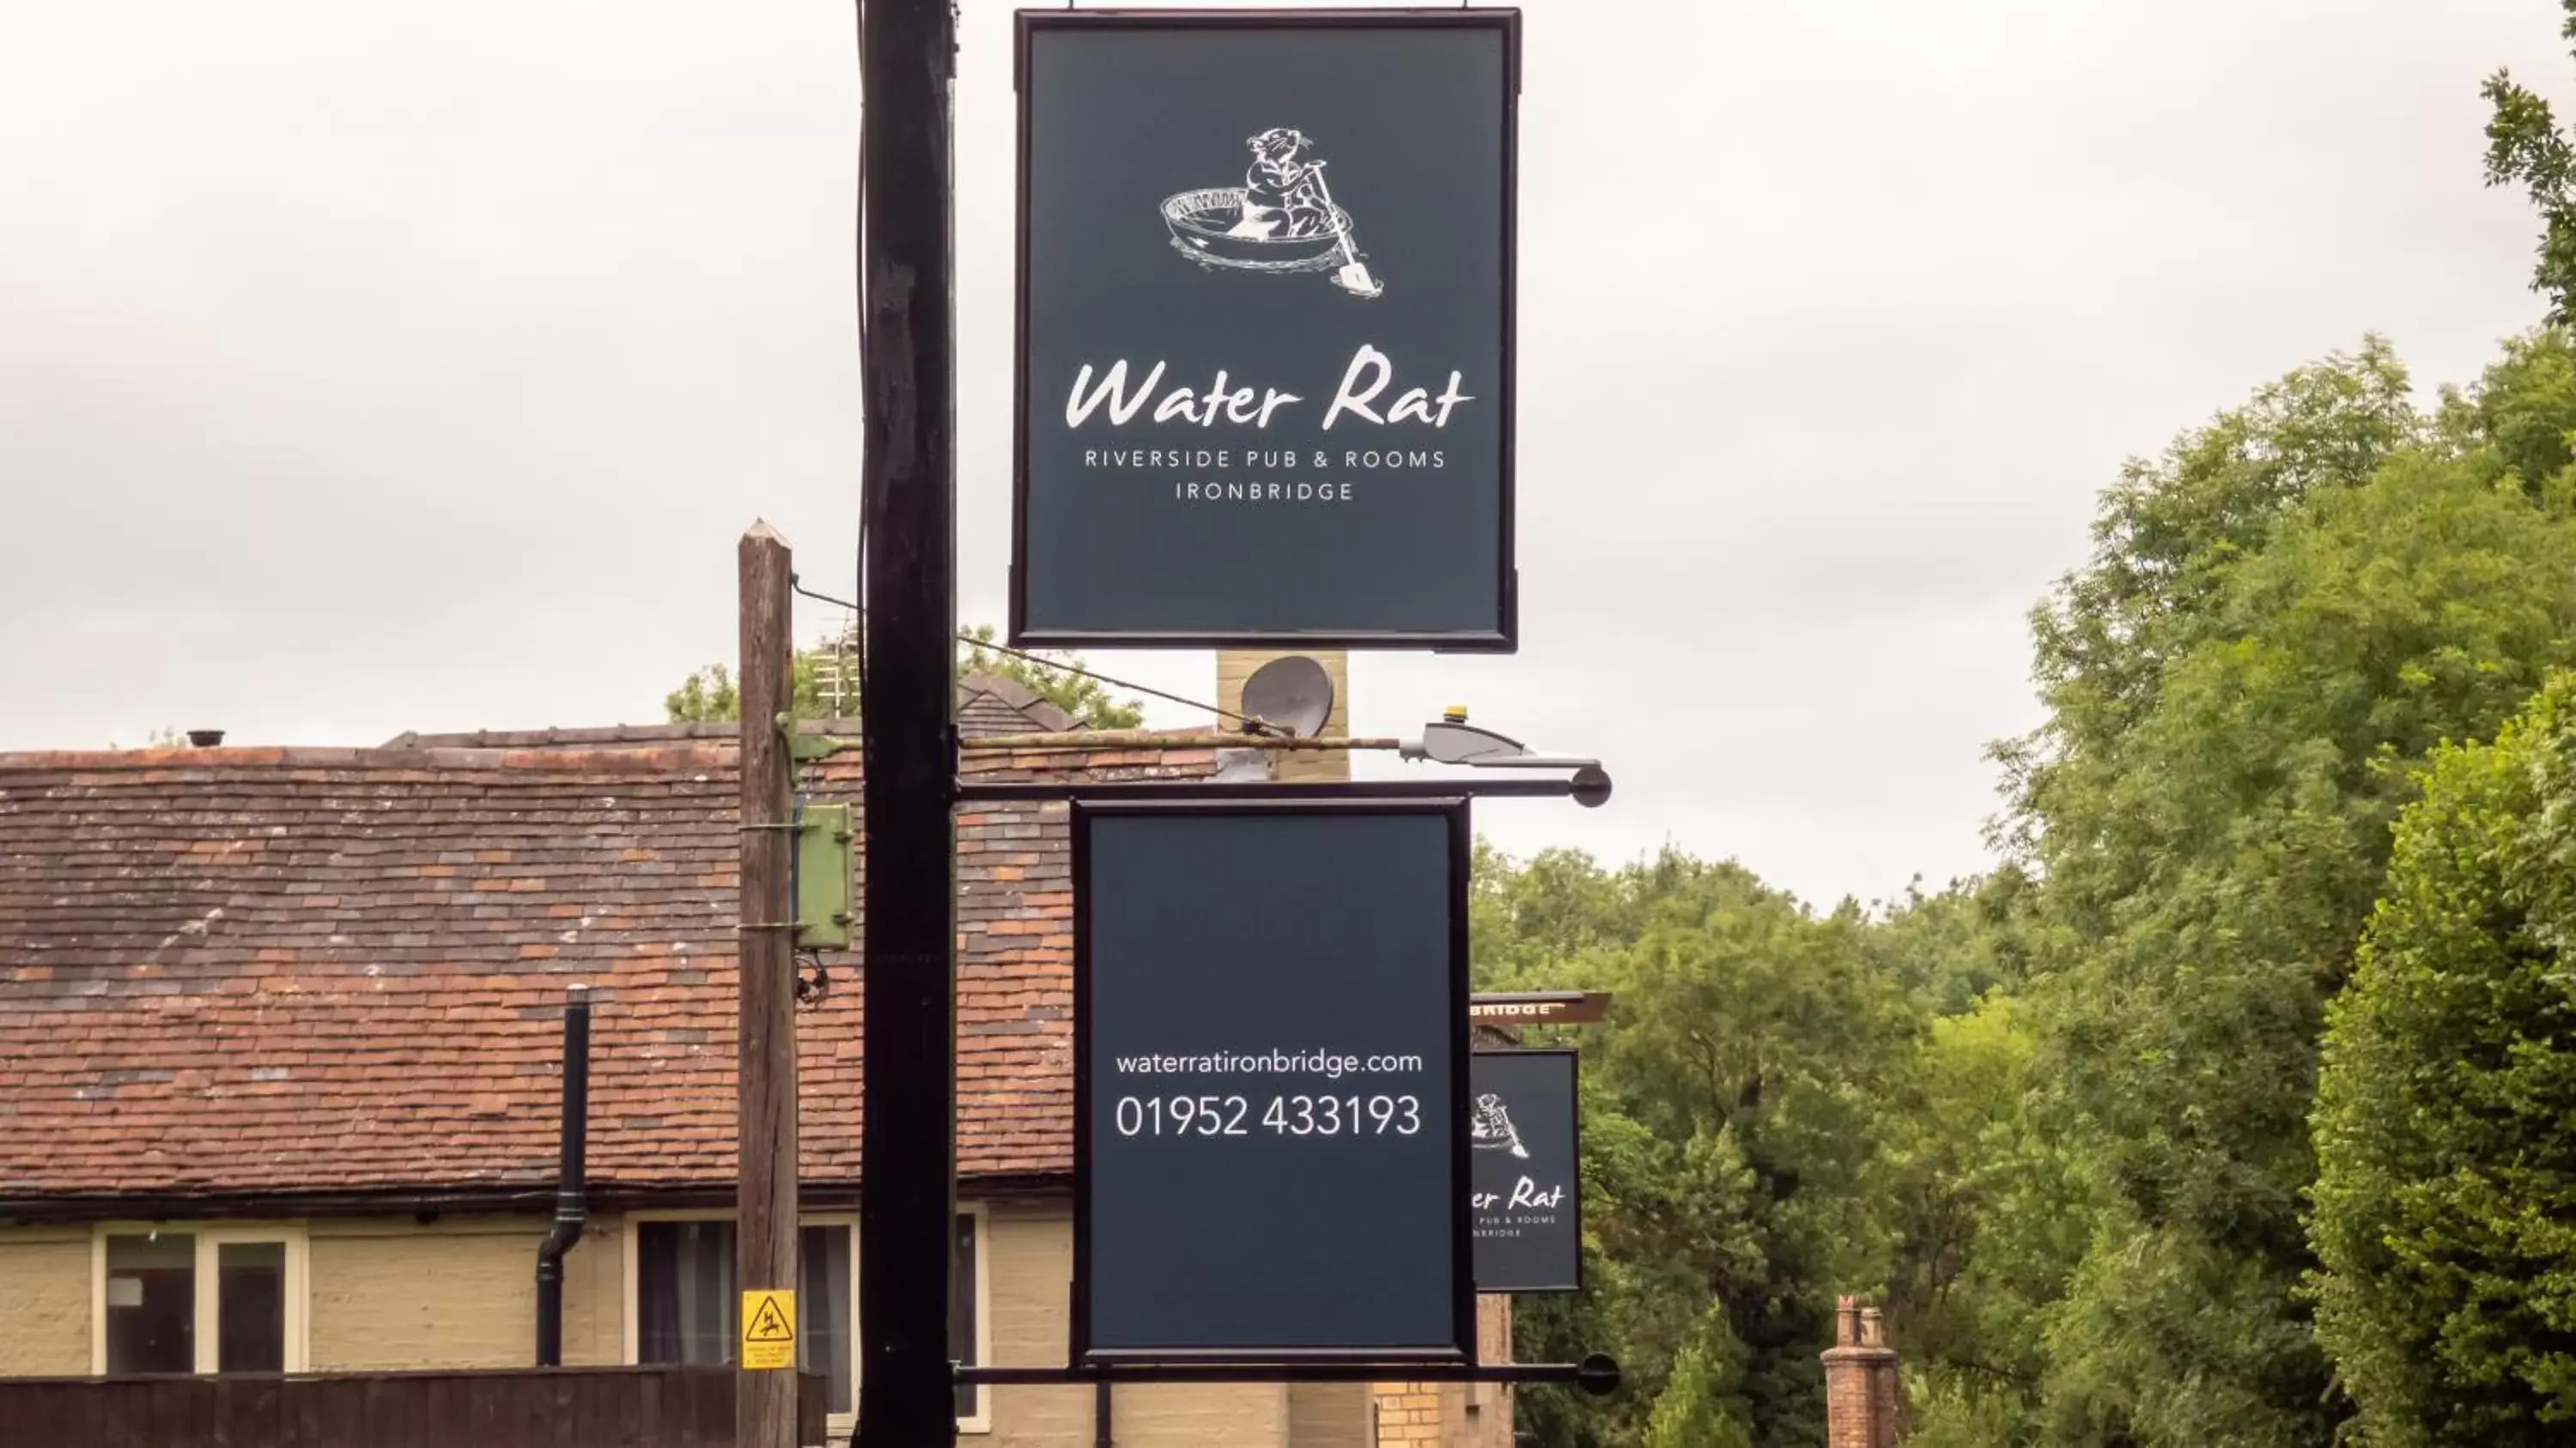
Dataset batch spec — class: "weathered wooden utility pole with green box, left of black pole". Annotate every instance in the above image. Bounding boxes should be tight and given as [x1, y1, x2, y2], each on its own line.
[734, 523, 796, 1448]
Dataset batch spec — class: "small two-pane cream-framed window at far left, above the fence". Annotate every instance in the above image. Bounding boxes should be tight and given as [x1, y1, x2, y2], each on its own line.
[90, 1226, 304, 1373]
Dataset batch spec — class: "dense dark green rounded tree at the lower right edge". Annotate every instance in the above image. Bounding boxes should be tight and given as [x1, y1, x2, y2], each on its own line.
[2313, 675, 2576, 1448]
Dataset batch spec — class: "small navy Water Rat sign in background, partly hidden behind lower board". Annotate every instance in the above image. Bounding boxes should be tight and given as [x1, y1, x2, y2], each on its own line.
[1468, 1051, 1584, 1293]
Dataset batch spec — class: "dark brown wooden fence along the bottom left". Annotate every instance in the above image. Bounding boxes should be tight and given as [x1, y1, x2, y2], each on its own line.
[0, 1368, 829, 1448]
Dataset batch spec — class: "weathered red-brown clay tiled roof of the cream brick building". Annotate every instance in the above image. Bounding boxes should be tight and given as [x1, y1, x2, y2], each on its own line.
[0, 706, 1211, 1196]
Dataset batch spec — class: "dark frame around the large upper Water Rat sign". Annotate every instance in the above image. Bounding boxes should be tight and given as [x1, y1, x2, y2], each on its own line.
[1005, 5, 1520, 654]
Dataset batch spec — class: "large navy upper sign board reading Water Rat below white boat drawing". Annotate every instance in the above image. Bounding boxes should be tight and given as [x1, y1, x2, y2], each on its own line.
[1010, 10, 1520, 652]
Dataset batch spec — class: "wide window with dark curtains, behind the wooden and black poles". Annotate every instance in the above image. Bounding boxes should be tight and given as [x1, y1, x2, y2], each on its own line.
[629, 1211, 987, 1430]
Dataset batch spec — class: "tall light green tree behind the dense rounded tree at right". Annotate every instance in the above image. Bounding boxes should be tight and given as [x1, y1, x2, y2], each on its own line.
[2002, 335, 2576, 1448]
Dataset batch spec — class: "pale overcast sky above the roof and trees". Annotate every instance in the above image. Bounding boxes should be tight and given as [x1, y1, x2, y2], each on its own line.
[0, 0, 2576, 902]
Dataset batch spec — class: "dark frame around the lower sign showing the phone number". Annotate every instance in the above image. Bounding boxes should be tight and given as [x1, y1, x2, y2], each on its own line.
[1066, 796, 1479, 1371]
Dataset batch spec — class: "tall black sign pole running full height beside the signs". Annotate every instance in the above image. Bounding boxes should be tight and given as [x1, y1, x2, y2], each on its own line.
[858, 0, 956, 1448]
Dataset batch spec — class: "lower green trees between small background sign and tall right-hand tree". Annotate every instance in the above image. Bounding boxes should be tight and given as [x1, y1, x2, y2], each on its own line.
[1473, 850, 2084, 1448]
